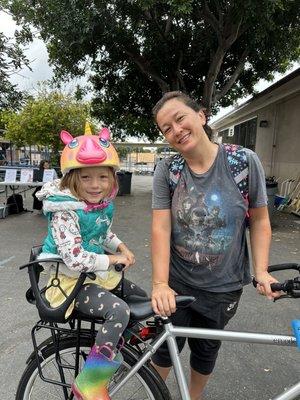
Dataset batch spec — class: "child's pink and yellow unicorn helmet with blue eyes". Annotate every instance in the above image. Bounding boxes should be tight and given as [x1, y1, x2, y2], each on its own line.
[60, 123, 120, 175]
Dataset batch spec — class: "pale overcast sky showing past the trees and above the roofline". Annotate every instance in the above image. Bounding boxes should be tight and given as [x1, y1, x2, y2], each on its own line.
[0, 11, 300, 122]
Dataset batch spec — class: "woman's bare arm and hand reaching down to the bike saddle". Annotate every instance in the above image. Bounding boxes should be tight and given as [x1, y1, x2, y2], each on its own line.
[151, 209, 176, 316]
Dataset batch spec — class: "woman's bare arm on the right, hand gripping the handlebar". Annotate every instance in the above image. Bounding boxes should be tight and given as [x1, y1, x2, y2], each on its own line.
[249, 206, 280, 299]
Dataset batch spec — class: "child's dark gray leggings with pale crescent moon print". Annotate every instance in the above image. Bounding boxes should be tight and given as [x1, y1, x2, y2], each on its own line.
[75, 279, 147, 351]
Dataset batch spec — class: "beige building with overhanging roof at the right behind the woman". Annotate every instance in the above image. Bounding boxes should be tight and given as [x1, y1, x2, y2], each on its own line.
[211, 68, 300, 179]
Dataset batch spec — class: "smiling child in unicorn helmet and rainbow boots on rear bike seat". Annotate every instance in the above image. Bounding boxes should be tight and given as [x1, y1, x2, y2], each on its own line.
[38, 123, 146, 400]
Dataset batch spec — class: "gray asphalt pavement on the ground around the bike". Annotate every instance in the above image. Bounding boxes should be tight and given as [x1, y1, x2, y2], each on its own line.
[0, 175, 300, 400]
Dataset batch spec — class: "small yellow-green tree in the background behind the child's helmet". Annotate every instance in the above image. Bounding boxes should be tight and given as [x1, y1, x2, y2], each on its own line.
[3, 88, 89, 162]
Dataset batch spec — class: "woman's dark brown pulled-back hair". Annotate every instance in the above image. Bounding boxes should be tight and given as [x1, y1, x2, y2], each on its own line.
[152, 90, 212, 139]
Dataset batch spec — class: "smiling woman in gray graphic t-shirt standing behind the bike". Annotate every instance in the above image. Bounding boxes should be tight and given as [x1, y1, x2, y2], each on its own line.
[152, 92, 278, 400]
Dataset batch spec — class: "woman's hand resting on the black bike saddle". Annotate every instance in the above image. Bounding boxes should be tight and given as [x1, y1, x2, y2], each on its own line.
[151, 283, 177, 317]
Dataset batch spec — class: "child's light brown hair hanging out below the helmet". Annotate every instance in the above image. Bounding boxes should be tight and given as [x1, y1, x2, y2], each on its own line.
[60, 167, 119, 199]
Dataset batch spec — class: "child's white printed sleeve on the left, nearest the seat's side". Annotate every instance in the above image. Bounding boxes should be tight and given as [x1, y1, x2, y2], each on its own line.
[51, 211, 109, 272]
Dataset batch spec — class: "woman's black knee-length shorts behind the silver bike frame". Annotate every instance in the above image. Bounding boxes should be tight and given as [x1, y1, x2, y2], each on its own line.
[152, 282, 243, 375]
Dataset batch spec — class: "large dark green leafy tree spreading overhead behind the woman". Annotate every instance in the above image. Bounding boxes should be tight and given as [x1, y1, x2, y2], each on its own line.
[2, 0, 300, 139]
